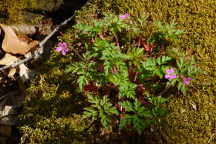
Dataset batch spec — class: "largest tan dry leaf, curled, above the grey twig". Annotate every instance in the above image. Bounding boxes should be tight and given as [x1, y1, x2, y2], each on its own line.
[0, 24, 38, 55]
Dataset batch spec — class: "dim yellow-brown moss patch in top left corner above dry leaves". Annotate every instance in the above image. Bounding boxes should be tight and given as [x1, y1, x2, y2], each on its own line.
[0, 0, 63, 24]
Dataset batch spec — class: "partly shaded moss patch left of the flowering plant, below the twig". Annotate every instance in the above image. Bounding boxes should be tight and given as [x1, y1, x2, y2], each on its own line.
[19, 54, 92, 144]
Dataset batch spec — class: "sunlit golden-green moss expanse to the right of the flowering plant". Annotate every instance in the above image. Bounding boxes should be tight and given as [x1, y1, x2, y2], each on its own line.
[115, 0, 216, 144]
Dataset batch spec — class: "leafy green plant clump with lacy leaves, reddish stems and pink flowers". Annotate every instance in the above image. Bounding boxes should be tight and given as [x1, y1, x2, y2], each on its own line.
[61, 14, 198, 134]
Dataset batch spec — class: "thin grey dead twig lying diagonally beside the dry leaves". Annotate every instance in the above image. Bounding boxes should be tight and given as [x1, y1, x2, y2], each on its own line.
[0, 15, 74, 71]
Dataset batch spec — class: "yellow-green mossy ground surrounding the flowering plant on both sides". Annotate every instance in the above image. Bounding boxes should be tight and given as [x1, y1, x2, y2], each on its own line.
[0, 0, 216, 144]
